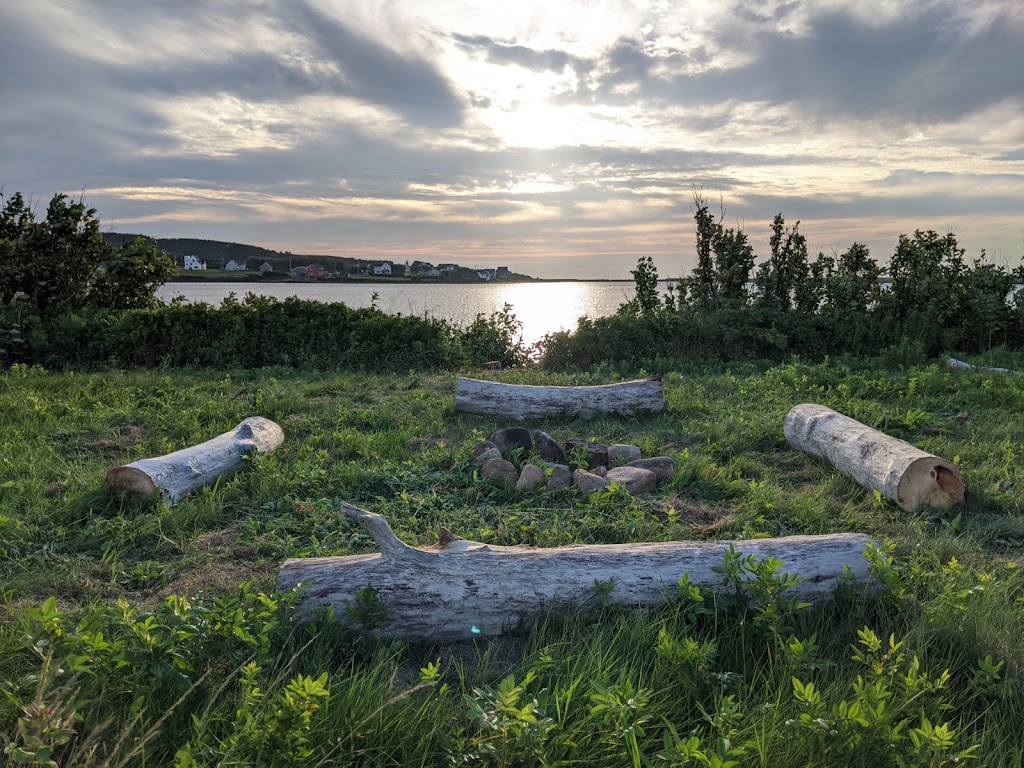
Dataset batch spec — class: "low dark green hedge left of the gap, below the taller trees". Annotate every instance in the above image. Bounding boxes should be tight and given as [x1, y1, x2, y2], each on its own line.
[0, 294, 523, 371]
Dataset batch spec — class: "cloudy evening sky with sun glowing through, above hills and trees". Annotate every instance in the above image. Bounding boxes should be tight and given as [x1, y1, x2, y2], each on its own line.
[0, 0, 1024, 280]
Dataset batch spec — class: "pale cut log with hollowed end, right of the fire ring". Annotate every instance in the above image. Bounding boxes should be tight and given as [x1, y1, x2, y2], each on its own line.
[783, 402, 965, 512]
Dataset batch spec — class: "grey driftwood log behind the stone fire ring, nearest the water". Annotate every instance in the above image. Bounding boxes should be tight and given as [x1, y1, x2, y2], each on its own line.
[455, 376, 665, 421]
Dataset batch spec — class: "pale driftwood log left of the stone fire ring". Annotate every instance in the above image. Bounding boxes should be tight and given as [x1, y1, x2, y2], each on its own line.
[104, 416, 285, 506]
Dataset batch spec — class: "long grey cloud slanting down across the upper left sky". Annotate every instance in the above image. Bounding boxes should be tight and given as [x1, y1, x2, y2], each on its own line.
[0, 2, 465, 128]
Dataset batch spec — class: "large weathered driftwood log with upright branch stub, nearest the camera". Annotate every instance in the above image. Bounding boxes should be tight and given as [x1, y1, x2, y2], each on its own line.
[278, 503, 869, 640]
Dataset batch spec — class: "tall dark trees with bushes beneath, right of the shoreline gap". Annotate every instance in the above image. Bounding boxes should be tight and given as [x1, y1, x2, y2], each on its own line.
[543, 190, 1024, 368]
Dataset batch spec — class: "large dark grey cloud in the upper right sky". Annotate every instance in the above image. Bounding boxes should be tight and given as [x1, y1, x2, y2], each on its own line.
[581, 4, 1024, 123]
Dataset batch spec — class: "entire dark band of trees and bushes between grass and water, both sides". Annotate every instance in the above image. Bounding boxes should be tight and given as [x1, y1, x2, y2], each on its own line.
[0, 191, 1024, 371]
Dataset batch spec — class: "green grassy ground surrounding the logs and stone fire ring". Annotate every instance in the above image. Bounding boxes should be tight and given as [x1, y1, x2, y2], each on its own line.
[0, 359, 1024, 766]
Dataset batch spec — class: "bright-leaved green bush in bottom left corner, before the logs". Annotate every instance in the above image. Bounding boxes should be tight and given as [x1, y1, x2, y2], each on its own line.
[0, 585, 307, 766]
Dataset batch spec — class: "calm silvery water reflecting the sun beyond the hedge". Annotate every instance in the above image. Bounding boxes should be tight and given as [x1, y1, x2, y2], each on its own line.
[157, 281, 664, 344]
